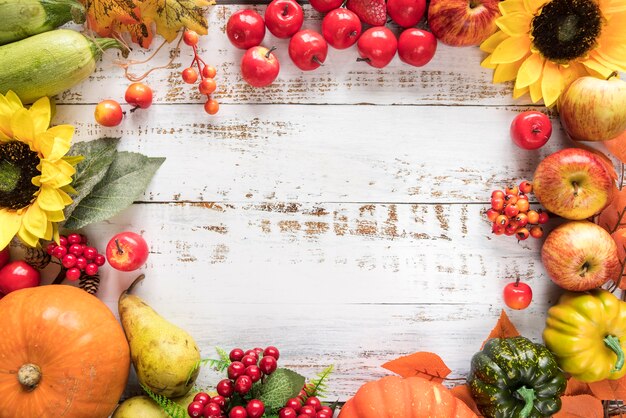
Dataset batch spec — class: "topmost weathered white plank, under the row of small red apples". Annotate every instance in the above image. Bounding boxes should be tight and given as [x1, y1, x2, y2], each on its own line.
[60, 5, 530, 105]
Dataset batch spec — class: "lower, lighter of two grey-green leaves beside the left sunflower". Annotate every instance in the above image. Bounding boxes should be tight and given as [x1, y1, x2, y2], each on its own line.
[65, 152, 165, 229]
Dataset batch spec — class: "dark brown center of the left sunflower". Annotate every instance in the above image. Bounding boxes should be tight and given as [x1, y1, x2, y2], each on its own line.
[0, 141, 41, 210]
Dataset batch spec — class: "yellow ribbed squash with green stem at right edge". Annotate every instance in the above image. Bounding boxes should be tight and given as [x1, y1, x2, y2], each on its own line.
[543, 289, 626, 382]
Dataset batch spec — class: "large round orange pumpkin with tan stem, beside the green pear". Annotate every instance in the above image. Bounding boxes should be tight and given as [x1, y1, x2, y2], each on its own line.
[0, 285, 130, 418]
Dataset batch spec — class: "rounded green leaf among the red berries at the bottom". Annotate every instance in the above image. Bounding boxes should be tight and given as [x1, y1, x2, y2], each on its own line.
[259, 369, 305, 414]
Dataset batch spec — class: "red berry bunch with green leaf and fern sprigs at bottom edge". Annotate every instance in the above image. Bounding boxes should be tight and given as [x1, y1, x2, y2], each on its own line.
[187, 346, 333, 418]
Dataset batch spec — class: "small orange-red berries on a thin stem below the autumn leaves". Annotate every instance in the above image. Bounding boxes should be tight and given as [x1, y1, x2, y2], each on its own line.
[182, 29, 220, 115]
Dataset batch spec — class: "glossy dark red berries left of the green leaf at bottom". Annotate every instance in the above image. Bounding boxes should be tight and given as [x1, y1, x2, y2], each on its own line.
[187, 346, 280, 418]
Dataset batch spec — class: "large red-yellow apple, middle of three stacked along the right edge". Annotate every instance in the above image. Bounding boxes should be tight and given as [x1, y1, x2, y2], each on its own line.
[533, 148, 615, 220]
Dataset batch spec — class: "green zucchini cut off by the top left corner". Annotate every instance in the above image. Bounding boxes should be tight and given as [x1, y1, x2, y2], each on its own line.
[0, 0, 85, 45]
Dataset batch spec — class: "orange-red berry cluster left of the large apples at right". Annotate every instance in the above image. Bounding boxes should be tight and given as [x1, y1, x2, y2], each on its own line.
[487, 180, 548, 241]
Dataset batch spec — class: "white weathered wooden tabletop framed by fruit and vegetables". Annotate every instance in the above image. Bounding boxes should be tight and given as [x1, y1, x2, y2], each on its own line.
[55, 5, 566, 400]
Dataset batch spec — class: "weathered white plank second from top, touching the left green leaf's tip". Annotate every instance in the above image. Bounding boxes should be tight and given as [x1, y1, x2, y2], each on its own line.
[55, 105, 567, 203]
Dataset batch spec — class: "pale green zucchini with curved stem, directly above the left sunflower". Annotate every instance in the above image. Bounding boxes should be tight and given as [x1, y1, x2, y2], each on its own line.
[0, 29, 126, 103]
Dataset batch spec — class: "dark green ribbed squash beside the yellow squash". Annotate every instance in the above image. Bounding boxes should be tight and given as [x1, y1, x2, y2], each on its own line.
[467, 337, 567, 418]
